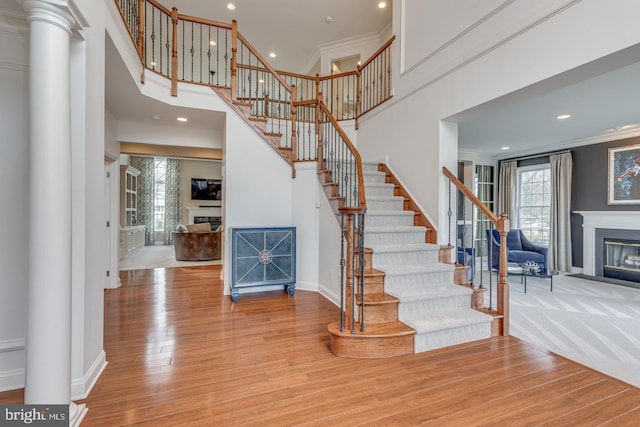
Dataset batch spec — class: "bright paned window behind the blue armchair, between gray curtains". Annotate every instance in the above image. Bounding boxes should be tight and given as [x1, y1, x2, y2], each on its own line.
[518, 164, 551, 246]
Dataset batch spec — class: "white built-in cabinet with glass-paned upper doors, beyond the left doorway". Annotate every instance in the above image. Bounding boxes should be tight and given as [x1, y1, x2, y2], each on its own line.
[120, 165, 145, 259]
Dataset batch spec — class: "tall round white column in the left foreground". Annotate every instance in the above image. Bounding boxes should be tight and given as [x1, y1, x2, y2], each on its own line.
[22, 0, 76, 414]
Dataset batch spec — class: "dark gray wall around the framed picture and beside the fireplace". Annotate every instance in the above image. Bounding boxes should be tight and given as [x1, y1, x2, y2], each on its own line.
[571, 137, 640, 268]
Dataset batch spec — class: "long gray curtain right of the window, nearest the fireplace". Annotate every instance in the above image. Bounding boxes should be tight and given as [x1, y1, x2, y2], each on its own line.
[549, 153, 573, 271]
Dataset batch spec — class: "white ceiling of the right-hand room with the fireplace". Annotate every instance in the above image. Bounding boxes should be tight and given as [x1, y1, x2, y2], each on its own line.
[449, 42, 640, 159]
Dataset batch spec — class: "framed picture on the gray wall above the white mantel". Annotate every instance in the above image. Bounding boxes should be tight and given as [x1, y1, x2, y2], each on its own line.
[608, 144, 640, 205]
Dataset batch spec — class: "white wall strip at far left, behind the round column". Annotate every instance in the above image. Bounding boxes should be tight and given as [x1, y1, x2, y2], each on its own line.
[0, 5, 29, 391]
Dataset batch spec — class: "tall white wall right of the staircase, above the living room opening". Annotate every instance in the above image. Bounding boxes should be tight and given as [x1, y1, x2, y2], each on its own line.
[358, 0, 640, 243]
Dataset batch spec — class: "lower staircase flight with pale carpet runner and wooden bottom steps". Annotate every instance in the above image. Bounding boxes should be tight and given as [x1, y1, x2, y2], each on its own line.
[329, 163, 494, 358]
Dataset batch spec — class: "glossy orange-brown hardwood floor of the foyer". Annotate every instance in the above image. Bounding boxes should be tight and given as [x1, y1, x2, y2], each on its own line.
[0, 266, 640, 426]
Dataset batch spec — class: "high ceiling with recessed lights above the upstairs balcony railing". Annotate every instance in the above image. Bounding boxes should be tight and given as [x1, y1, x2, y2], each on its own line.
[168, 0, 393, 73]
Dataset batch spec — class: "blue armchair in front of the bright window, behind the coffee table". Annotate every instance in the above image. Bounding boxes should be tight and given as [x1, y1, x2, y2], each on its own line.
[487, 228, 549, 273]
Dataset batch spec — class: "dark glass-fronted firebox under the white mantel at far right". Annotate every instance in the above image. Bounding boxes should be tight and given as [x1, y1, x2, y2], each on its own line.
[602, 238, 640, 282]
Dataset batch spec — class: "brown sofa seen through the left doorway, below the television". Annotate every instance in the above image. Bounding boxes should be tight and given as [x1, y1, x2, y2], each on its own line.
[173, 222, 222, 261]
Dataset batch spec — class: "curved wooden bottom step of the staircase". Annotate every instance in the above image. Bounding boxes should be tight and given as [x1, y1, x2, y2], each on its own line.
[327, 322, 415, 359]
